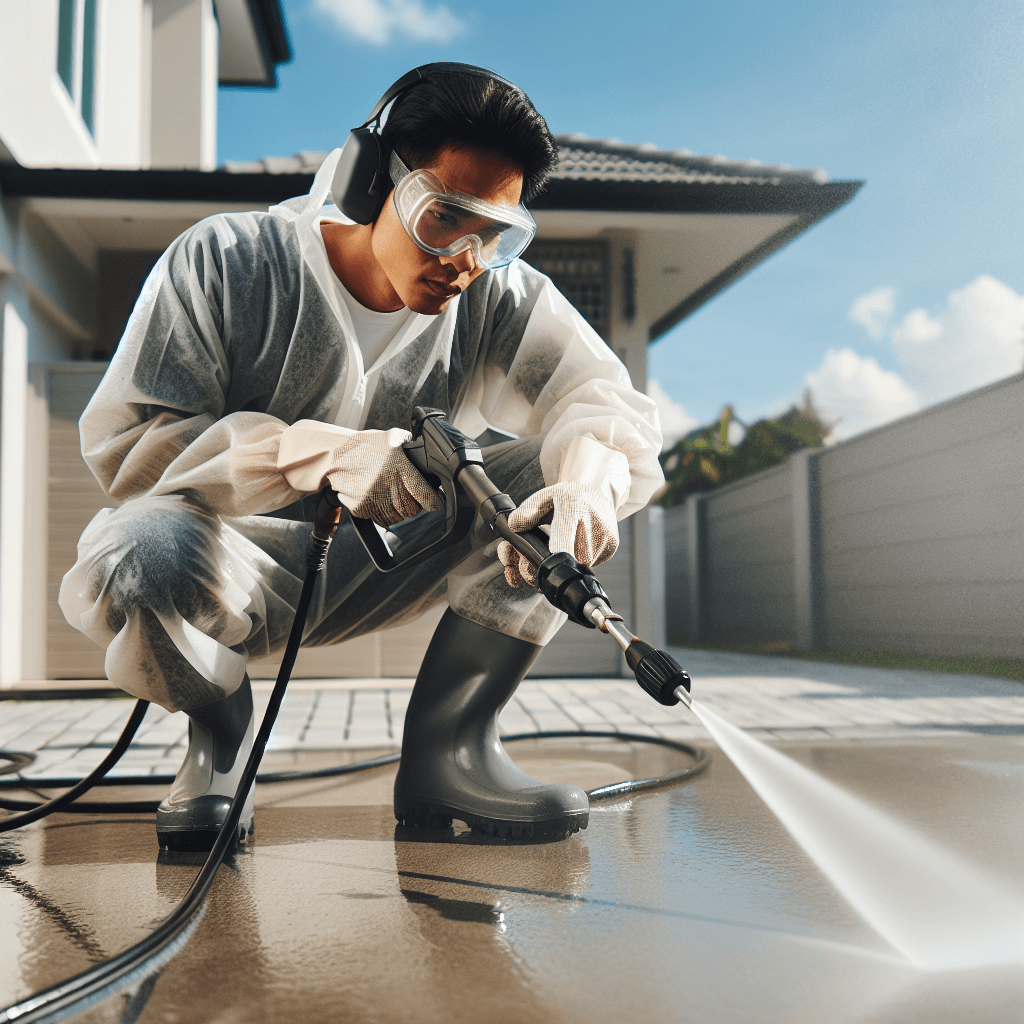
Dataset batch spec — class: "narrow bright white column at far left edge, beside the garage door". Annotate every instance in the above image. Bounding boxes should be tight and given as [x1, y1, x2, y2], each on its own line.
[0, 302, 29, 686]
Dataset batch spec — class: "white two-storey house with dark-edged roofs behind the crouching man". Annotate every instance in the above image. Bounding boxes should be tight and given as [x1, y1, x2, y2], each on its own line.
[0, 0, 859, 686]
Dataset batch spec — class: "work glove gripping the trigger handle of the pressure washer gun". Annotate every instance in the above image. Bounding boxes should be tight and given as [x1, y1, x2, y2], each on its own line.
[325, 427, 444, 526]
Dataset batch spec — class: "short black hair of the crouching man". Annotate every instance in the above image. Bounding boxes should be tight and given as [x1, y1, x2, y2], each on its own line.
[381, 72, 558, 203]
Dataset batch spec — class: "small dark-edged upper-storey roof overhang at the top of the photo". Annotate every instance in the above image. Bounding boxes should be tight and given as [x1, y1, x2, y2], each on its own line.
[214, 0, 292, 89]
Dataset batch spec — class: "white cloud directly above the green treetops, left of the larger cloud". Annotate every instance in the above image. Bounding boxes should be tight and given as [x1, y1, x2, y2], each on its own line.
[804, 348, 921, 441]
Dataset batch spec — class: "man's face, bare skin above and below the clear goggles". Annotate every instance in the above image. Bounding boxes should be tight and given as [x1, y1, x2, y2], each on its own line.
[371, 146, 522, 315]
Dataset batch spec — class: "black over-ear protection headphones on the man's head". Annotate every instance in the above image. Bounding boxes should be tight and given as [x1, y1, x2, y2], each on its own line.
[331, 61, 519, 224]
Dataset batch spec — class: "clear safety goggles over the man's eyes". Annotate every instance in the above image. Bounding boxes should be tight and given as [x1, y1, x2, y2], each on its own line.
[391, 152, 537, 270]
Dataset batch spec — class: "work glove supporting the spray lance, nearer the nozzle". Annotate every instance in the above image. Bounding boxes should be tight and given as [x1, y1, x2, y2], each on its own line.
[498, 481, 618, 587]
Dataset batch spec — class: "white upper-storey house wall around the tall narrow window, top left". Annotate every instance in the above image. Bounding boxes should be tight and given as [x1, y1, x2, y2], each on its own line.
[0, 0, 221, 170]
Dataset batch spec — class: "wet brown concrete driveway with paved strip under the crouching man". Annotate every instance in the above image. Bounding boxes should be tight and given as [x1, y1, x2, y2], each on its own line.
[0, 651, 1024, 1024]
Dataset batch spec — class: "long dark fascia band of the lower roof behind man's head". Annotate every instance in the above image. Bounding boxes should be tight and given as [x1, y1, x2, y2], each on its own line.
[0, 164, 862, 219]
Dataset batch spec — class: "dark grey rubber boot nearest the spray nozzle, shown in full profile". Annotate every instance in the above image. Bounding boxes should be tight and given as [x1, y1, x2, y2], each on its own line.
[394, 609, 590, 840]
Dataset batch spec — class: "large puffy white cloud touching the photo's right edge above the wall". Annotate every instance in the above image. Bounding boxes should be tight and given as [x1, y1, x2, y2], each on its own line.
[892, 274, 1024, 406]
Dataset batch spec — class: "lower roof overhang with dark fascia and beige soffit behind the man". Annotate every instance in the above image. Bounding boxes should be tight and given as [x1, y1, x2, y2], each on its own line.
[0, 165, 861, 341]
